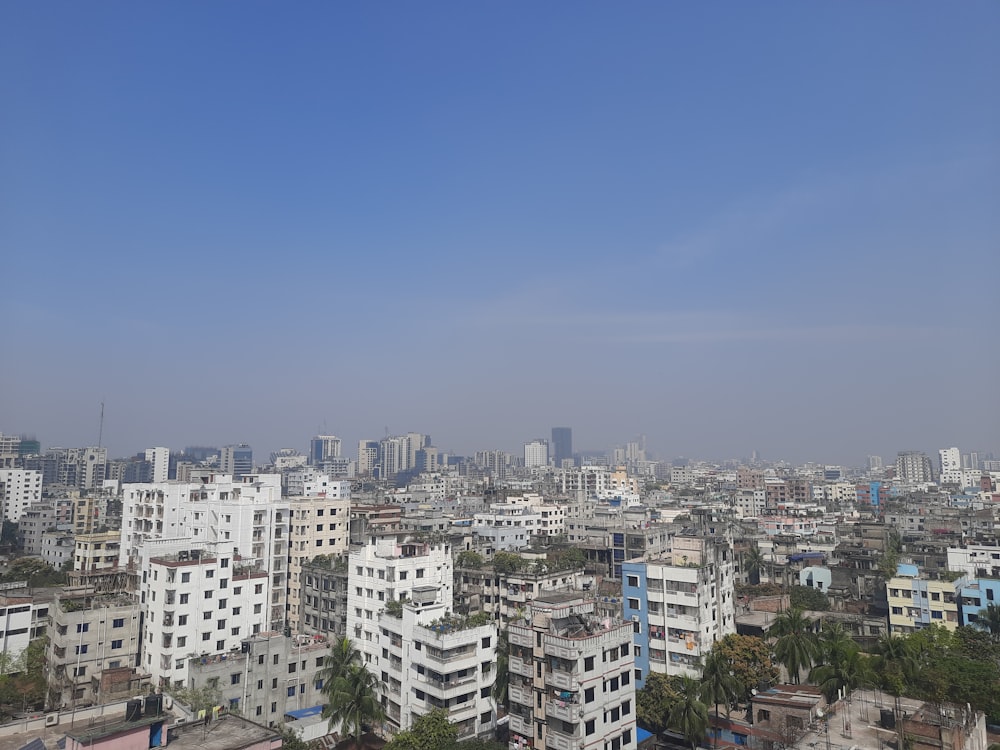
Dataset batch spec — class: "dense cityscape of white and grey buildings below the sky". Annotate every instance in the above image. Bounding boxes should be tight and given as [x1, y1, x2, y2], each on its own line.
[0, 434, 1000, 750]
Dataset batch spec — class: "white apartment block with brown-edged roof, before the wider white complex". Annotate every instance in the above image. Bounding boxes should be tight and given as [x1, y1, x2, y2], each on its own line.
[140, 542, 269, 686]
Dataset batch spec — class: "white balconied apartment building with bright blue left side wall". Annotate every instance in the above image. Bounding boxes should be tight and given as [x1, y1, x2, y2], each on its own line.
[622, 536, 736, 688]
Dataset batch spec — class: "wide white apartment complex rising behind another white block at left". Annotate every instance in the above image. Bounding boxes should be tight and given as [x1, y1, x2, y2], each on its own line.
[119, 474, 289, 630]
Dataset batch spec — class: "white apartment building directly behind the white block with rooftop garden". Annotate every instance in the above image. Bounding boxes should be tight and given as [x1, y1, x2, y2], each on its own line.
[347, 535, 454, 670]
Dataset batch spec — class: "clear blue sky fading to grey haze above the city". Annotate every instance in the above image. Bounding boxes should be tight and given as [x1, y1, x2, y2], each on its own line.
[0, 0, 1000, 465]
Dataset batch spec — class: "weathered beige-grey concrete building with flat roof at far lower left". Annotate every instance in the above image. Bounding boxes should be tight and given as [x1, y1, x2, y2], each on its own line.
[45, 587, 148, 707]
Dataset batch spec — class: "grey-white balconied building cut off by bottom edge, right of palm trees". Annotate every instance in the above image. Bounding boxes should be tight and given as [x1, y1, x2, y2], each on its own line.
[508, 594, 637, 750]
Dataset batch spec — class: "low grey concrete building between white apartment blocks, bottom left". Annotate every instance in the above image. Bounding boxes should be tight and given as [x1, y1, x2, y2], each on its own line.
[186, 632, 330, 726]
